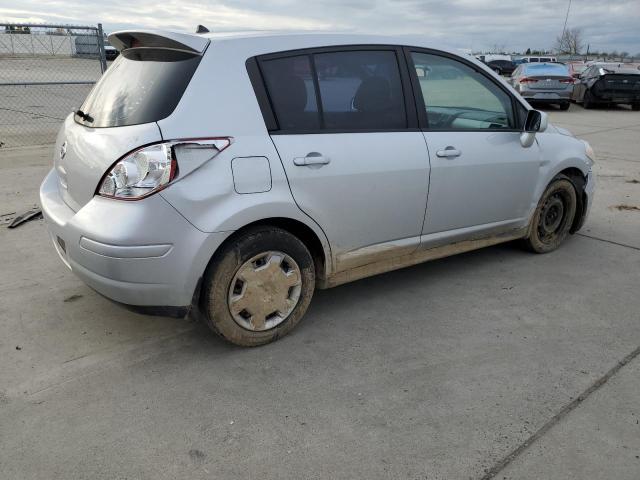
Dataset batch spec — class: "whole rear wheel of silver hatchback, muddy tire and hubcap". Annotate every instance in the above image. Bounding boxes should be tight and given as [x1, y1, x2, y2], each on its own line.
[201, 226, 315, 347]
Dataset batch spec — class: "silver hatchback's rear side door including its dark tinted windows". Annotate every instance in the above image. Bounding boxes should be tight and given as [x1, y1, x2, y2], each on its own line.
[259, 46, 429, 271]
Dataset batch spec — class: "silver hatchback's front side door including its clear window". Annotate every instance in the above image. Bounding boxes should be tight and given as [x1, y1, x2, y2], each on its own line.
[407, 49, 541, 247]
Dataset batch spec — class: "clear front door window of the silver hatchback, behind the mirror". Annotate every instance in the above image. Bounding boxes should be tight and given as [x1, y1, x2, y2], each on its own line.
[411, 52, 516, 130]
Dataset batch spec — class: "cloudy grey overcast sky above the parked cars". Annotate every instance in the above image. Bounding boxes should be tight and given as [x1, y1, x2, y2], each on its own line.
[0, 0, 640, 55]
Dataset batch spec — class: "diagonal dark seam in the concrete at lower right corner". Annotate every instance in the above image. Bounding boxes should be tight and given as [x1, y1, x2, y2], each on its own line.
[480, 346, 640, 480]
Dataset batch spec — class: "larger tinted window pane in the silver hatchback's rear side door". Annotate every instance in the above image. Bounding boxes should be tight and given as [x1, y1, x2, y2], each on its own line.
[313, 50, 407, 130]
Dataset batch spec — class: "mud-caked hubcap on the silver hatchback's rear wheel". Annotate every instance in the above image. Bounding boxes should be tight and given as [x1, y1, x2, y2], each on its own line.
[228, 251, 302, 332]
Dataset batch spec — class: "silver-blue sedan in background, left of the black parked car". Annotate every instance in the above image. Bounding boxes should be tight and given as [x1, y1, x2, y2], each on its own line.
[510, 63, 574, 110]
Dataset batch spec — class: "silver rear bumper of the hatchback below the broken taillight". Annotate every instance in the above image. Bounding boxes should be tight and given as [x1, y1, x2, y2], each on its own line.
[40, 170, 228, 308]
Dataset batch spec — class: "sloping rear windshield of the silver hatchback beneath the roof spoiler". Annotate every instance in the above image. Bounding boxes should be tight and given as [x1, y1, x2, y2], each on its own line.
[75, 48, 201, 127]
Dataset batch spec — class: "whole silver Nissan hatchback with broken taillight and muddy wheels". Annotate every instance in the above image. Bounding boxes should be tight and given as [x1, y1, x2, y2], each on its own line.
[40, 31, 594, 346]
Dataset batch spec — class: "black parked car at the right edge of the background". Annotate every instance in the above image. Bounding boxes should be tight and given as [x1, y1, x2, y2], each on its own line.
[571, 63, 640, 111]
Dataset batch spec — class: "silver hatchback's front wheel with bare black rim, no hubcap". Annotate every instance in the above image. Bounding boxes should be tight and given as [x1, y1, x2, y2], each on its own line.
[525, 175, 578, 253]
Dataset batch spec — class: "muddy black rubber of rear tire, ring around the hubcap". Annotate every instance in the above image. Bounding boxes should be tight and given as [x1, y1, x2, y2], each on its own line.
[201, 226, 315, 347]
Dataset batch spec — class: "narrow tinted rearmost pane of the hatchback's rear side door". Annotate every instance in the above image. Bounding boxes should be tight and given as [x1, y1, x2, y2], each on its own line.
[260, 55, 320, 130]
